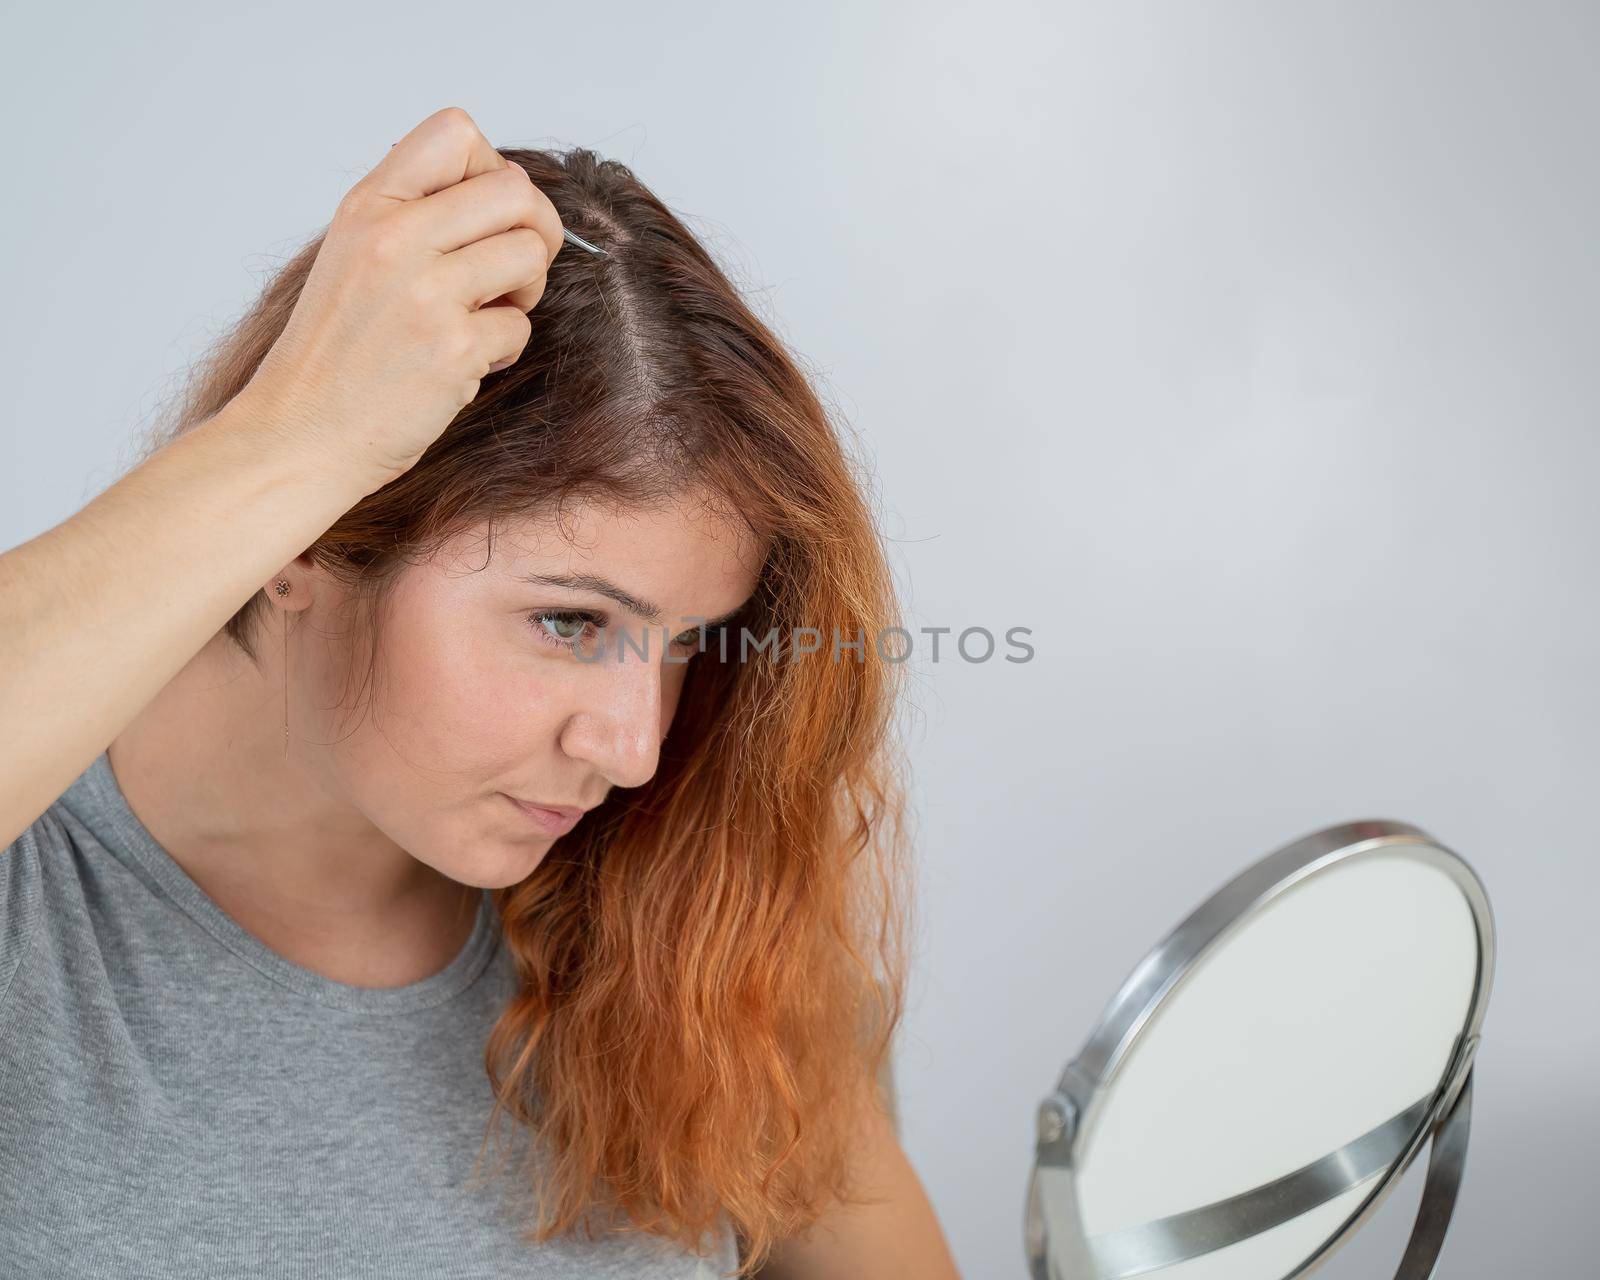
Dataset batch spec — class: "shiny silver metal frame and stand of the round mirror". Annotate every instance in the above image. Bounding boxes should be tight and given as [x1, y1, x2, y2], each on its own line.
[1022, 819, 1494, 1280]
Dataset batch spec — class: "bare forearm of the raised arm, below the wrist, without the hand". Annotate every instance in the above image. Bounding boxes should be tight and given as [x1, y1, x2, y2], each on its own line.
[0, 398, 363, 848]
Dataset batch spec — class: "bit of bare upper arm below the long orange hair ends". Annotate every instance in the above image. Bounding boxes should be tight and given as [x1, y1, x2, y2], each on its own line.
[757, 1109, 960, 1280]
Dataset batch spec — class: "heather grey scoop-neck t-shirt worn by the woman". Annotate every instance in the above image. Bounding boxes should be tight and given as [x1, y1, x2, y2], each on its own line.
[0, 752, 736, 1280]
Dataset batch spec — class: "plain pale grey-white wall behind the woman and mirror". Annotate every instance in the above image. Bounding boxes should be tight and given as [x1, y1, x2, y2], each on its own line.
[0, 0, 1600, 1280]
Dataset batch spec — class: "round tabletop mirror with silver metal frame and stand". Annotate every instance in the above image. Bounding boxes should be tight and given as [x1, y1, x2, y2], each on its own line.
[1024, 821, 1494, 1280]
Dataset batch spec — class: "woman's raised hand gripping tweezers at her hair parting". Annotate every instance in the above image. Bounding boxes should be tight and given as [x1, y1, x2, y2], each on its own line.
[240, 107, 563, 493]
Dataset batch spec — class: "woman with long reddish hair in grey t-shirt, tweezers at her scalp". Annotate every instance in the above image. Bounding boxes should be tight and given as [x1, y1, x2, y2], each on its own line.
[0, 109, 955, 1280]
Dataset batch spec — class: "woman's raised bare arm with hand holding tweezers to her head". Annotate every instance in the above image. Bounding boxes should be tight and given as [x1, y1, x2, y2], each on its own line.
[0, 107, 562, 846]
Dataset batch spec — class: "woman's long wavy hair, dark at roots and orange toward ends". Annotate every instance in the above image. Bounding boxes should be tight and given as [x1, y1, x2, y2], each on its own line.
[137, 149, 910, 1275]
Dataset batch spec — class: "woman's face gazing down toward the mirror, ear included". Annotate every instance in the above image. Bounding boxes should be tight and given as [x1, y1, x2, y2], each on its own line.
[290, 496, 762, 888]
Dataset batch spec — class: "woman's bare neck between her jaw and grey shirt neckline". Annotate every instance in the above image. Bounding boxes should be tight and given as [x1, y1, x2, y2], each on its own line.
[107, 635, 478, 987]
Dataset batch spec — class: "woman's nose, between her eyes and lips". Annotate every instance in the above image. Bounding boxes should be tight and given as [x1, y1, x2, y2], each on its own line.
[562, 640, 674, 787]
